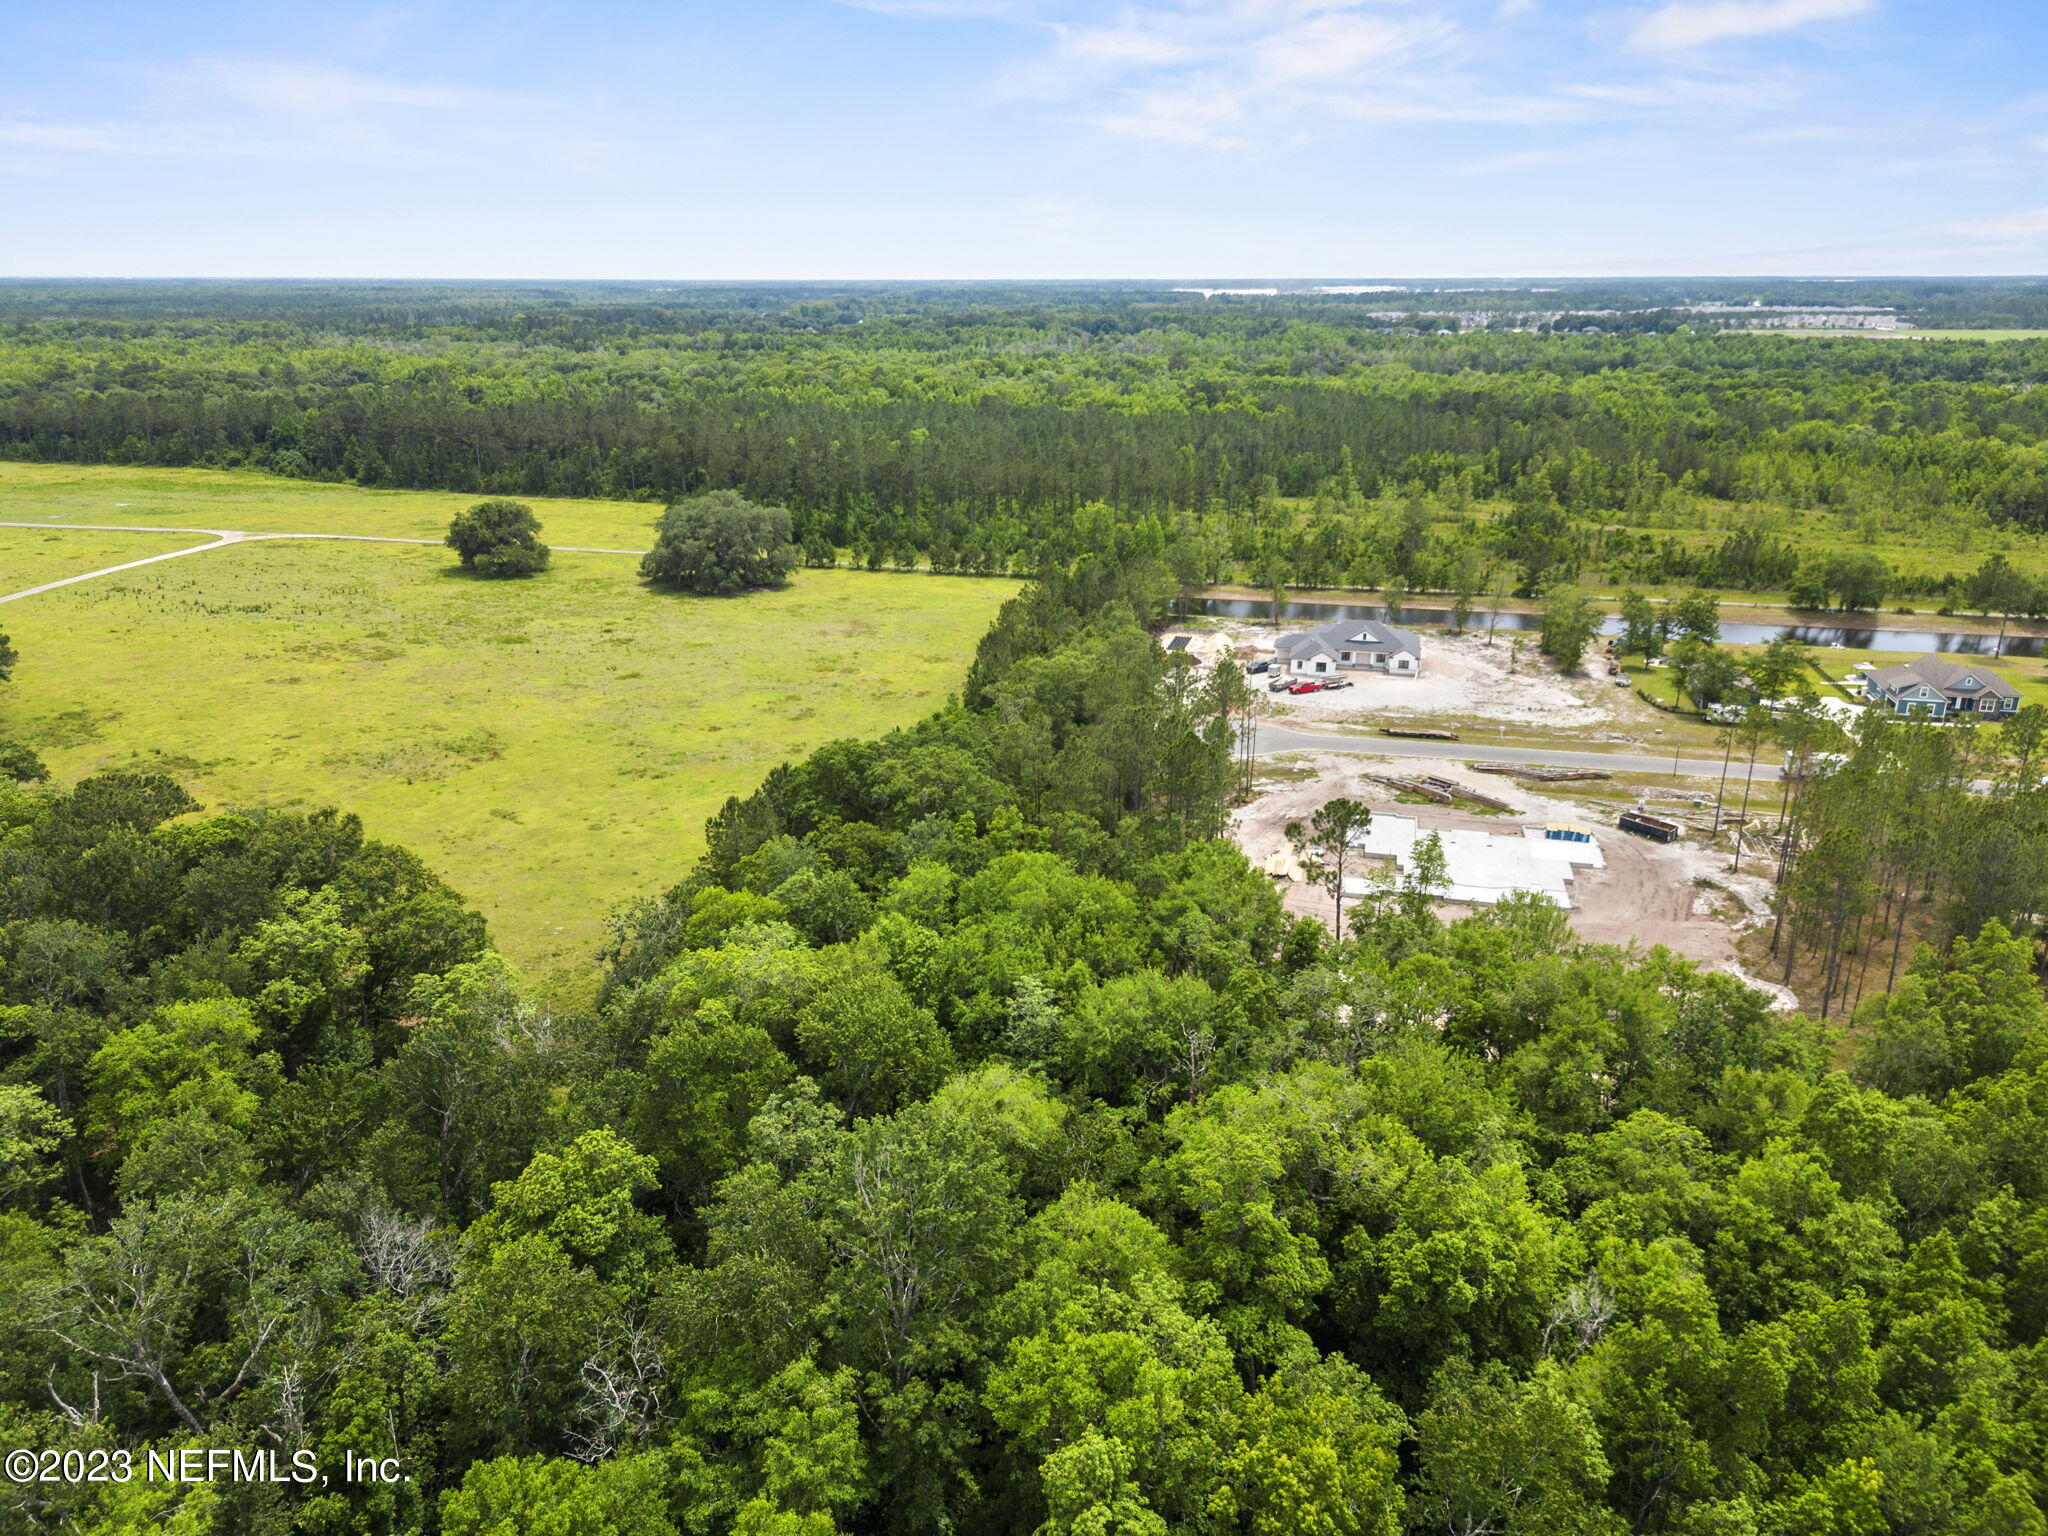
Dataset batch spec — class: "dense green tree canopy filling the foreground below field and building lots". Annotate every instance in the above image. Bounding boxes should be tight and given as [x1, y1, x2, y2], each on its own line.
[0, 543, 2048, 1536]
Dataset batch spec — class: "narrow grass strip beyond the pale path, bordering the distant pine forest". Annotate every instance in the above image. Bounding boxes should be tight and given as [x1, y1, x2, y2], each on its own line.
[0, 463, 662, 559]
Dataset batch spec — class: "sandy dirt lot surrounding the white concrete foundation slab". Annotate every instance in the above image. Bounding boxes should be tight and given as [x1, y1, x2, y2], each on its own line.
[1233, 753, 1792, 1006]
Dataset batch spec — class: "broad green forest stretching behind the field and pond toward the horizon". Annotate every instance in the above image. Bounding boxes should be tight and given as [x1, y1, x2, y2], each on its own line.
[0, 285, 2048, 608]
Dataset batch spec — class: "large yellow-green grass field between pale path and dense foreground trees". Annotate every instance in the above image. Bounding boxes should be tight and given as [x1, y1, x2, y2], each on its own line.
[0, 528, 1016, 975]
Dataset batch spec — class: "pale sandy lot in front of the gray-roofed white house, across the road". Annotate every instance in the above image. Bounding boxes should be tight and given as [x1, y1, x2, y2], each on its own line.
[1219, 627, 1634, 731]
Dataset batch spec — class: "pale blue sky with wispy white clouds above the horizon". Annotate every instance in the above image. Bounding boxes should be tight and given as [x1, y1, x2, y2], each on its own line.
[0, 0, 2048, 279]
